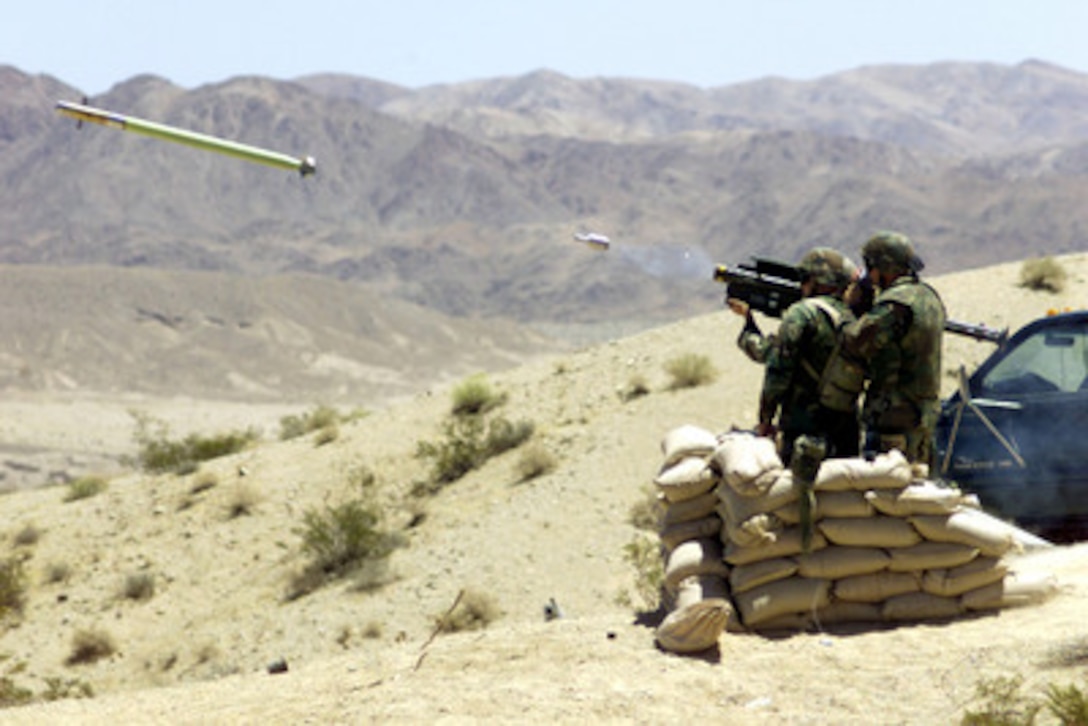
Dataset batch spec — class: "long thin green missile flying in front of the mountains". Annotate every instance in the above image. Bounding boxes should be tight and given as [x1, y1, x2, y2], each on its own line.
[57, 101, 318, 176]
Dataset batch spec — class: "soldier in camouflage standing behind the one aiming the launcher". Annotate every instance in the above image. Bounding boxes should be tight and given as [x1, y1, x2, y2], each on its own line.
[842, 232, 945, 468]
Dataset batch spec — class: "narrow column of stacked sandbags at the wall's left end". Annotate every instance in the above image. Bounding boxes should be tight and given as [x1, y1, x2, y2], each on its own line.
[654, 426, 733, 653]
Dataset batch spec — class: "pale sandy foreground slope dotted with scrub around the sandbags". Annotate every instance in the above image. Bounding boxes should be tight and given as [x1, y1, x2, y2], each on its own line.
[0, 255, 1088, 724]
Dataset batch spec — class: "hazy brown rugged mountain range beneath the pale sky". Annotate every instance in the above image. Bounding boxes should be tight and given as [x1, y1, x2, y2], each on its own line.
[0, 61, 1088, 402]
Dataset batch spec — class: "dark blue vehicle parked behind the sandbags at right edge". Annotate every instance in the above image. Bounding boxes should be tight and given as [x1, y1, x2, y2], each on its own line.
[937, 311, 1088, 541]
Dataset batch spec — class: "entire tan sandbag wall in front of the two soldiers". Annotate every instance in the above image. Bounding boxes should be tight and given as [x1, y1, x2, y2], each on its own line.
[655, 426, 1055, 652]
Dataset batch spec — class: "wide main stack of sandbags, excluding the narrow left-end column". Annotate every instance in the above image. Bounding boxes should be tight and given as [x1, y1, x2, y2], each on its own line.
[709, 432, 1054, 630]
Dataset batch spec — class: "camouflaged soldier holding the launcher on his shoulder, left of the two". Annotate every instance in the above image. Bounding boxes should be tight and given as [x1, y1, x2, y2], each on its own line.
[738, 247, 860, 465]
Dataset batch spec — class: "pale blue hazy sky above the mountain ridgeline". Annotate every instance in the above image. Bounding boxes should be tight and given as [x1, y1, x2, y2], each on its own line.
[8, 0, 1088, 95]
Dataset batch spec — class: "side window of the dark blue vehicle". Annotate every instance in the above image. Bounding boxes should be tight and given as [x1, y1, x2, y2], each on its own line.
[980, 327, 1088, 395]
